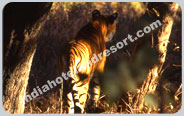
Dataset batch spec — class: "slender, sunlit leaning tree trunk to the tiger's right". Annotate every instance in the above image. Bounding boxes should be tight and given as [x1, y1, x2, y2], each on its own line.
[134, 3, 179, 113]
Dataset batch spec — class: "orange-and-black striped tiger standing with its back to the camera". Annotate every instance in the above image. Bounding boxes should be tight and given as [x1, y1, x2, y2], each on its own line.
[58, 10, 118, 114]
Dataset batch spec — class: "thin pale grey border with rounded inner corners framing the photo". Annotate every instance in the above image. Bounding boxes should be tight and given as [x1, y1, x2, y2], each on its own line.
[0, 0, 184, 116]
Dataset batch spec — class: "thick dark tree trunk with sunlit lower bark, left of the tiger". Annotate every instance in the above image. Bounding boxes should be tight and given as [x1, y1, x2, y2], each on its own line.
[3, 3, 51, 113]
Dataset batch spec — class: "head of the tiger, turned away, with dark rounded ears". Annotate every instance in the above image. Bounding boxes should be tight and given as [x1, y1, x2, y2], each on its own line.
[92, 10, 118, 42]
